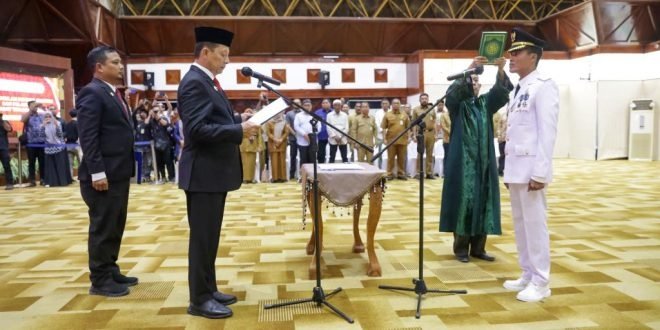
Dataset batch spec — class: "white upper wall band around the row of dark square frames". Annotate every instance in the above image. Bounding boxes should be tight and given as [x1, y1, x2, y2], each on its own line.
[127, 62, 407, 91]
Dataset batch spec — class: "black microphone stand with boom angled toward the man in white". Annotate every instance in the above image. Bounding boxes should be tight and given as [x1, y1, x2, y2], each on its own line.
[371, 87, 467, 318]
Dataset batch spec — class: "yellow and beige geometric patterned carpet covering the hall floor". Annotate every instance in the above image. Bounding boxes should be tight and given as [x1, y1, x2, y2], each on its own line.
[0, 160, 660, 329]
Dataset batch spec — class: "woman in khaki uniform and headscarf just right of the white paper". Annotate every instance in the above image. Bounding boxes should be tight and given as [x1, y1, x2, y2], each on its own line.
[266, 114, 292, 182]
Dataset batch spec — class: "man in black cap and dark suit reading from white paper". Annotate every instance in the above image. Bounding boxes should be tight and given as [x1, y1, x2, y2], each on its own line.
[178, 27, 259, 318]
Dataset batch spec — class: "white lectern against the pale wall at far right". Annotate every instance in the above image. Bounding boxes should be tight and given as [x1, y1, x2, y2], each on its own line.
[628, 99, 655, 160]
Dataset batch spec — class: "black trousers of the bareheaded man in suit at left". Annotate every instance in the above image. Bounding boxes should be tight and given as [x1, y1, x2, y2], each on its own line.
[80, 180, 130, 286]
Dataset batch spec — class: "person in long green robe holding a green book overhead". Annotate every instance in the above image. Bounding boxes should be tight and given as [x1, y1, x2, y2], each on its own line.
[440, 56, 513, 262]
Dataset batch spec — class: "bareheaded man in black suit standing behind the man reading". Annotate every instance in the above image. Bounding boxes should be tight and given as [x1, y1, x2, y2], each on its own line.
[76, 46, 138, 297]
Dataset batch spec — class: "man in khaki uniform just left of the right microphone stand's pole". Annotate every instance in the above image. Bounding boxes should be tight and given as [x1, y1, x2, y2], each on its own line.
[380, 99, 410, 180]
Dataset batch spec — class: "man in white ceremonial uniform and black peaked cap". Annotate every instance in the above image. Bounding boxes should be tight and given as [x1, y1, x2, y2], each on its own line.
[504, 28, 559, 302]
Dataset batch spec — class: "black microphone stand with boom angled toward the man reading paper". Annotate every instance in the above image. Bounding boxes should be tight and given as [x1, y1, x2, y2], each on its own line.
[257, 80, 373, 323]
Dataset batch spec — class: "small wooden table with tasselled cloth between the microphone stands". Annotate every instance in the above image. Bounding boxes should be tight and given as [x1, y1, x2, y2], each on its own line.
[301, 163, 385, 279]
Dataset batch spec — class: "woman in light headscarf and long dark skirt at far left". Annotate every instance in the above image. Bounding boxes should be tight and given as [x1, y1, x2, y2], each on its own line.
[40, 111, 73, 187]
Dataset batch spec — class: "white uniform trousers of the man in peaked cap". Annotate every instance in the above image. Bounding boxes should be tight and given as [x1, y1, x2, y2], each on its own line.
[509, 183, 550, 286]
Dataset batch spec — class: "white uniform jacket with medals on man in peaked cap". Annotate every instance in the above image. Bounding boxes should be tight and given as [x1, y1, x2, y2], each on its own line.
[504, 70, 559, 184]
